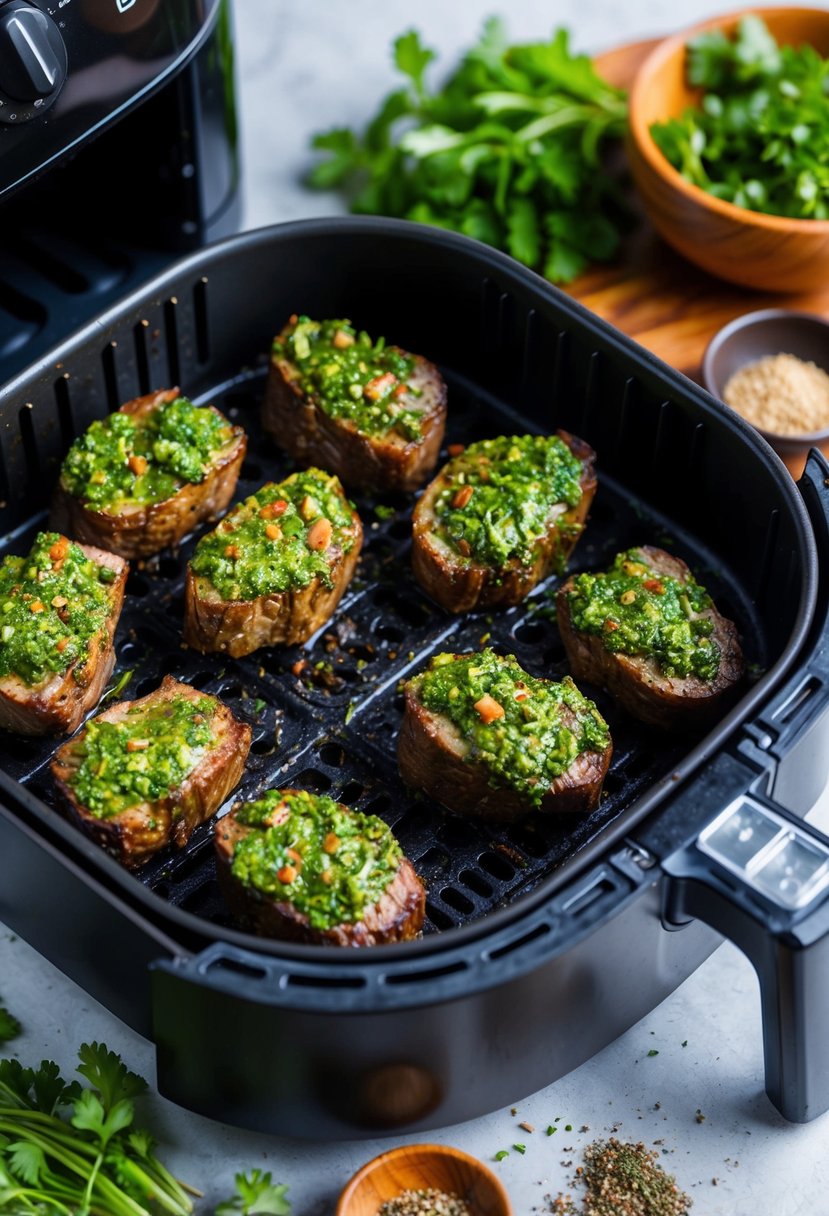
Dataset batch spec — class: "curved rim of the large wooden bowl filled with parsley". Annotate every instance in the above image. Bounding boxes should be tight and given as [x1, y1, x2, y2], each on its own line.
[628, 5, 829, 237]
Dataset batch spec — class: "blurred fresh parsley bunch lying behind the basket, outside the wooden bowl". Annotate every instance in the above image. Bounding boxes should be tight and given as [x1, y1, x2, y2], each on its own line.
[309, 18, 627, 282]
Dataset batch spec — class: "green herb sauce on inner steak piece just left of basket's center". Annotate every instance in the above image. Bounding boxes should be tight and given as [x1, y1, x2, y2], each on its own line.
[190, 468, 355, 599]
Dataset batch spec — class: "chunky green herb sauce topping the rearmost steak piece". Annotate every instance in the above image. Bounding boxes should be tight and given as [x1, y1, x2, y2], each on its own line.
[273, 316, 423, 443]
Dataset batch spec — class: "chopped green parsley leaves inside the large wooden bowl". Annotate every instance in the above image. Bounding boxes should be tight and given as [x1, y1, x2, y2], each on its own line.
[650, 16, 829, 220]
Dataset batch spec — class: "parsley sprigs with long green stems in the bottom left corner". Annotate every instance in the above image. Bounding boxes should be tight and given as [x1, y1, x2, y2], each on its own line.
[0, 1043, 193, 1216]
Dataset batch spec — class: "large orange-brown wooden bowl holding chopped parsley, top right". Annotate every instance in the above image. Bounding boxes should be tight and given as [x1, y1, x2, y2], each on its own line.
[627, 9, 829, 292]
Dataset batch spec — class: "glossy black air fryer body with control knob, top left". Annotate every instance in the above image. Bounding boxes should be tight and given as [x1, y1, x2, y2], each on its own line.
[0, 0, 241, 382]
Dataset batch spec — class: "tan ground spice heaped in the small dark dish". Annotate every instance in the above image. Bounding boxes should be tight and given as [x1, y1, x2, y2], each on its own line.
[722, 354, 829, 435]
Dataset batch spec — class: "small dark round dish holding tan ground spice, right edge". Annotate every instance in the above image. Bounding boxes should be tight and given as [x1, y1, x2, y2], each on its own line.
[703, 309, 829, 477]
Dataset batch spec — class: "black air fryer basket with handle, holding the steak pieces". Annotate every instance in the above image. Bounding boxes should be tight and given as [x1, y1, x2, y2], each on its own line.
[0, 220, 829, 1136]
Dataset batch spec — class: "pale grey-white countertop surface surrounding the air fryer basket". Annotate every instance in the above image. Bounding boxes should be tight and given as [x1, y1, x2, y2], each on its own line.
[0, 0, 829, 1216]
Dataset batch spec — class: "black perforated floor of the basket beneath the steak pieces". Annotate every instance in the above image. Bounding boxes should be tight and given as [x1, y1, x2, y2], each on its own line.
[0, 371, 766, 934]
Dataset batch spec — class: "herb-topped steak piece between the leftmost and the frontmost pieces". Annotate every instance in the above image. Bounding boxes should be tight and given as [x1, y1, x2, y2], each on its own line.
[51, 676, 250, 869]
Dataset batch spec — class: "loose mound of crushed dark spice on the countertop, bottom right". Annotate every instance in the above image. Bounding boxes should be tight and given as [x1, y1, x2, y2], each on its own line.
[551, 1138, 692, 1216]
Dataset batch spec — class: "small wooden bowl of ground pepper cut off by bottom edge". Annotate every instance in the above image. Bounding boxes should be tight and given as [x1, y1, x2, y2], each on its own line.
[337, 1144, 513, 1216]
